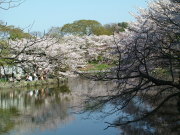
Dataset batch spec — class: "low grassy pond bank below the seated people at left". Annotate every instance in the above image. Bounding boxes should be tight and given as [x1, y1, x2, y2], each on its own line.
[0, 78, 67, 89]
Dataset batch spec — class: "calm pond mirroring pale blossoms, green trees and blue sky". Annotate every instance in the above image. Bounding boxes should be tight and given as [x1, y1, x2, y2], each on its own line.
[0, 78, 178, 135]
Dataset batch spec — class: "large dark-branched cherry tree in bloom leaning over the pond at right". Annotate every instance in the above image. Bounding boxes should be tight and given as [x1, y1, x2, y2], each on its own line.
[84, 0, 180, 129]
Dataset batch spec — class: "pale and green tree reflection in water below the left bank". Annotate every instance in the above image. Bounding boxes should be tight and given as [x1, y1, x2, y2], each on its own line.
[0, 85, 73, 132]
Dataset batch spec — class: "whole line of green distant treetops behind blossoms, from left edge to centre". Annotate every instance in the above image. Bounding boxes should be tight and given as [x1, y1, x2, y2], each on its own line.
[0, 20, 128, 38]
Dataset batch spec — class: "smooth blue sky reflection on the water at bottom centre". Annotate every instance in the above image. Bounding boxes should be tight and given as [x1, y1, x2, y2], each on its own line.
[27, 115, 119, 135]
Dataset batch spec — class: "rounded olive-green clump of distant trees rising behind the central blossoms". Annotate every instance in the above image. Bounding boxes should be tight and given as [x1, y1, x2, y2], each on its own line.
[48, 20, 128, 37]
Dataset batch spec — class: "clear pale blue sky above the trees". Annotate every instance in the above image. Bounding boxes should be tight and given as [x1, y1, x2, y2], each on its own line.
[0, 0, 148, 32]
